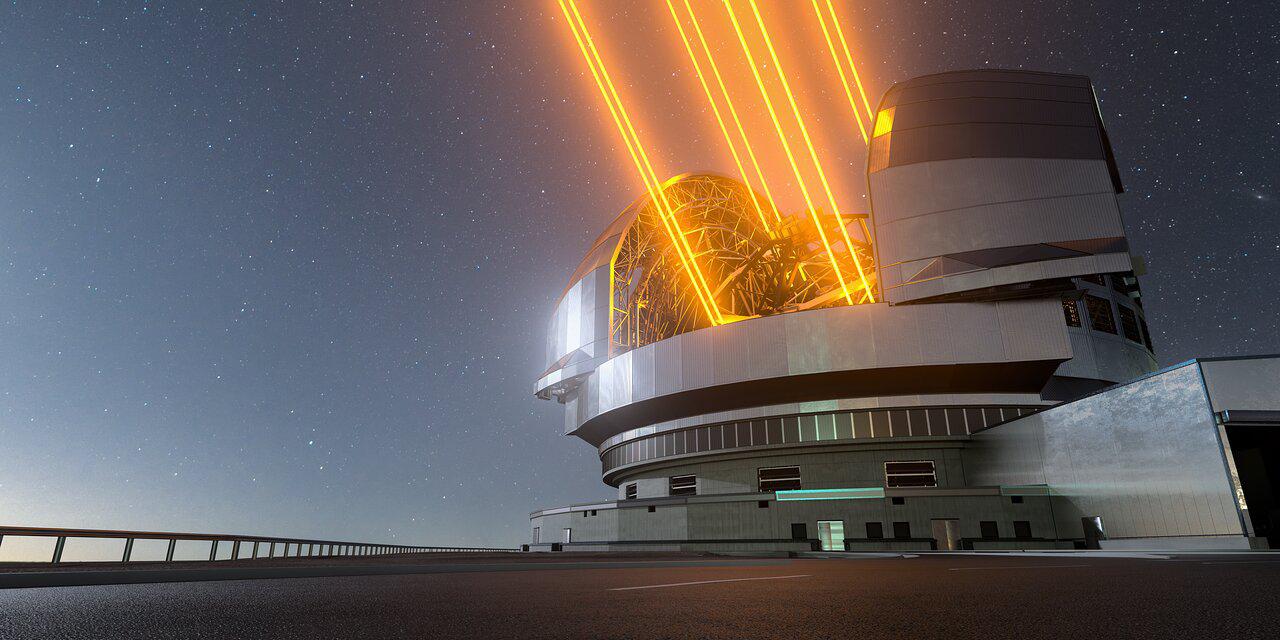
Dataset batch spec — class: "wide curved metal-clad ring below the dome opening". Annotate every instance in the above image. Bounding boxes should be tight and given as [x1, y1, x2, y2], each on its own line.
[573, 298, 1071, 444]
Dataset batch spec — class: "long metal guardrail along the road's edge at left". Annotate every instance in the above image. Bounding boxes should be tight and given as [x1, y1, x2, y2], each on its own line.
[0, 526, 520, 564]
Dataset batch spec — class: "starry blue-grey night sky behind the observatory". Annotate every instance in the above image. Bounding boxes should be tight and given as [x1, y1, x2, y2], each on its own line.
[0, 0, 1280, 545]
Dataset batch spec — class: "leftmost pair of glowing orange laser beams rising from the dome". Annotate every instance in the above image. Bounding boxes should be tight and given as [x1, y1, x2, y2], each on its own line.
[557, 0, 723, 325]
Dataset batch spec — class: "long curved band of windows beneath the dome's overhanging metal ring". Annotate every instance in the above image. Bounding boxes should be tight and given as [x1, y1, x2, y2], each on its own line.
[600, 407, 1038, 474]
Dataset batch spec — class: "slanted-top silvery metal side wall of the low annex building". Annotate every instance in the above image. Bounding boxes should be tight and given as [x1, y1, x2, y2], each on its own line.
[964, 366, 1244, 538]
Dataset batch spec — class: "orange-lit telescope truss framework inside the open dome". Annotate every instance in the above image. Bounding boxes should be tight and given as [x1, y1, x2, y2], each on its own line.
[609, 174, 876, 356]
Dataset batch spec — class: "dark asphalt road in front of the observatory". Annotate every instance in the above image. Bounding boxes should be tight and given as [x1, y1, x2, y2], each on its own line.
[0, 554, 1280, 640]
